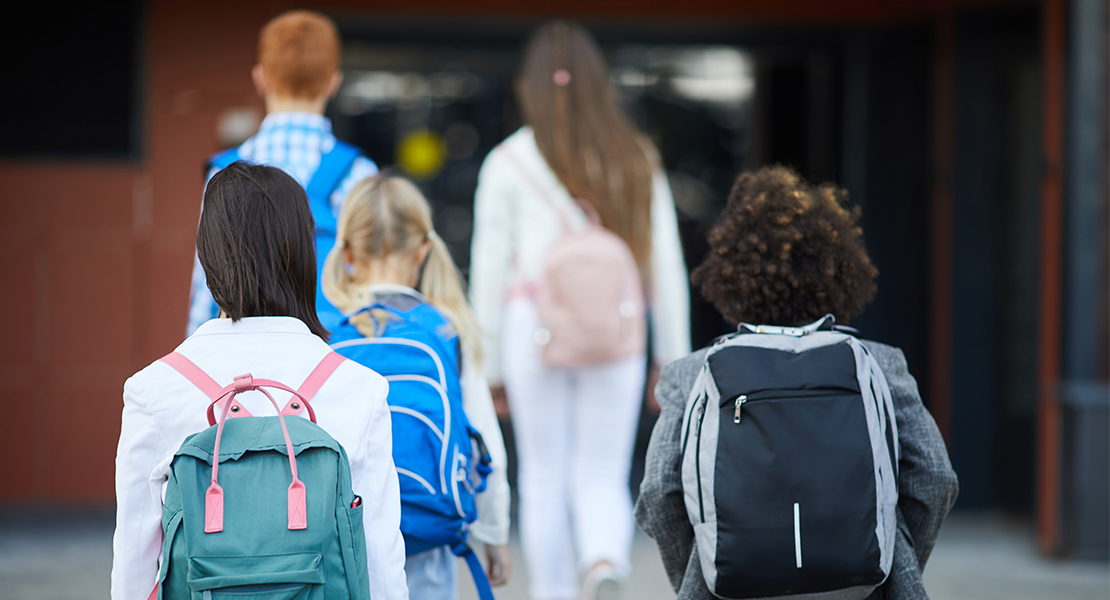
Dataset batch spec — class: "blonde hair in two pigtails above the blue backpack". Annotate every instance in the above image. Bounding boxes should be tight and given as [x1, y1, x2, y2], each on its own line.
[323, 175, 482, 360]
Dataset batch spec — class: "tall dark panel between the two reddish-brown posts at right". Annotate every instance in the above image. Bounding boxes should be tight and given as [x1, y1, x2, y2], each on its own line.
[949, 6, 1040, 512]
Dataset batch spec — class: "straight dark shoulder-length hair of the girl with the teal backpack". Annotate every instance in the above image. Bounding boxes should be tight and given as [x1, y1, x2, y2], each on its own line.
[196, 161, 329, 342]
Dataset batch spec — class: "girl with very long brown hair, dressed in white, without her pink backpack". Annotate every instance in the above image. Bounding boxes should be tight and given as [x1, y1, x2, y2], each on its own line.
[471, 21, 689, 599]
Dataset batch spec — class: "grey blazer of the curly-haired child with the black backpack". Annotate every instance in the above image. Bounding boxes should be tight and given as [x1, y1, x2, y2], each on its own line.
[636, 342, 959, 600]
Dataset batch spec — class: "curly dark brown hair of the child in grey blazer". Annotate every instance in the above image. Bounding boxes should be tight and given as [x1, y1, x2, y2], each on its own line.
[690, 166, 879, 326]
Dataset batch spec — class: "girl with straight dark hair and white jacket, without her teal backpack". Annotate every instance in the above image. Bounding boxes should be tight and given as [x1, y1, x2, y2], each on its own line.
[111, 161, 408, 600]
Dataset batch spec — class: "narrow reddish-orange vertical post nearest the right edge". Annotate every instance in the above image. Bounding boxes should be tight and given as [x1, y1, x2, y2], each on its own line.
[1037, 0, 1068, 553]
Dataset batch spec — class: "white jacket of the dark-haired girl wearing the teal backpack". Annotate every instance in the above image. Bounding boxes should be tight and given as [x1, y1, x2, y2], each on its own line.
[112, 317, 408, 600]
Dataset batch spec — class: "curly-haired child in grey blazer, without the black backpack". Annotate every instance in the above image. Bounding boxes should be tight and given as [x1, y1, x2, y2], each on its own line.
[636, 166, 958, 600]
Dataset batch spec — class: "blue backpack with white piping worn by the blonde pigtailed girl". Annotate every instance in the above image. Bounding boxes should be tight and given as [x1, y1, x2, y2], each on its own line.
[332, 303, 493, 600]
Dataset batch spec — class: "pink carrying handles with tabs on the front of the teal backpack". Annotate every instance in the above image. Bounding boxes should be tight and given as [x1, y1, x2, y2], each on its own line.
[204, 374, 306, 533]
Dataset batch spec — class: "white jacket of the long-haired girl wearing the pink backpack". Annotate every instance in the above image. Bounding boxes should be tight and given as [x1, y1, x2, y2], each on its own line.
[470, 126, 690, 385]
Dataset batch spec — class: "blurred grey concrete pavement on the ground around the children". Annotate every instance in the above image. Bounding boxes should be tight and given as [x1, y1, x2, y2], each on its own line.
[0, 509, 1110, 600]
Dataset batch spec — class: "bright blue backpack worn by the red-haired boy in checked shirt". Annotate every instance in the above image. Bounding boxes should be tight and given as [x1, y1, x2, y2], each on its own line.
[209, 140, 361, 330]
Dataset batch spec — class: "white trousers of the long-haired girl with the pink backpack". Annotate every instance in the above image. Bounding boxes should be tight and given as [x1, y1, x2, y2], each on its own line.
[502, 299, 646, 600]
